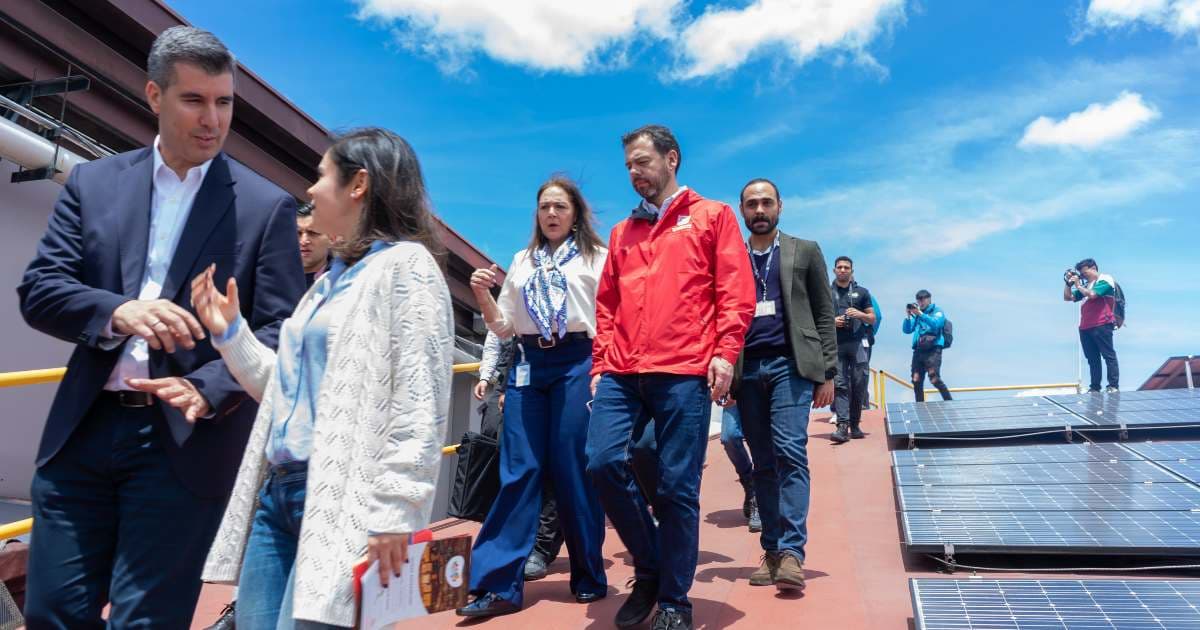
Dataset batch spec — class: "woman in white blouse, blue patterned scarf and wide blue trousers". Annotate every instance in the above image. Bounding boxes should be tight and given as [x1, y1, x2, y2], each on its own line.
[458, 176, 608, 617]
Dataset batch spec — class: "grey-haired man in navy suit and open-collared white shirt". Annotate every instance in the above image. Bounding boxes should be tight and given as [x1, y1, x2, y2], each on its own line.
[17, 26, 304, 630]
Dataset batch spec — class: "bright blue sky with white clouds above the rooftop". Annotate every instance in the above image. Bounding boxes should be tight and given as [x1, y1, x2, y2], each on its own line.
[172, 0, 1200, 398]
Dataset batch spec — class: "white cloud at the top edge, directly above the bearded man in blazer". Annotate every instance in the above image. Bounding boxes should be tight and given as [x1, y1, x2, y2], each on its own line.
[676, 0, 905, 78]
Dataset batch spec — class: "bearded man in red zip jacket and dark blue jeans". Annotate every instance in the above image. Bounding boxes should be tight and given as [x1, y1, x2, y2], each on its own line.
[587, 125, 755, 630]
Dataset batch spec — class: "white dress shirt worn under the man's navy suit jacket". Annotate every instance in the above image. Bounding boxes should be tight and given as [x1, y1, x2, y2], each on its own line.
[104, 136, 212, 391]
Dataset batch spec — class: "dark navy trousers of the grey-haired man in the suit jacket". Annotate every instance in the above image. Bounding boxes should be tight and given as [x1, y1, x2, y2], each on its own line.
[25, 398, 224, 630]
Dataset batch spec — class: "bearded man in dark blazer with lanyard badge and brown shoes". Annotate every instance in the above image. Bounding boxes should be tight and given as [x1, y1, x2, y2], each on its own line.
[733, 179, 838, 590]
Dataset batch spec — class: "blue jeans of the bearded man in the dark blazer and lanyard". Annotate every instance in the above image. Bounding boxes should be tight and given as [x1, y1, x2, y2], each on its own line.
[736, 356, 814, 562]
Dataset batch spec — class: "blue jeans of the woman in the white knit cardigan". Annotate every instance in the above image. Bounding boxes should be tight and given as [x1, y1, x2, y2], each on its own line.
[234, 462, 337, 630]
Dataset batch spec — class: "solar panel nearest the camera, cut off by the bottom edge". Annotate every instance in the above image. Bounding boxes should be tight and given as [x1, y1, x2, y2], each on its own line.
[908, 578, 1200, 630]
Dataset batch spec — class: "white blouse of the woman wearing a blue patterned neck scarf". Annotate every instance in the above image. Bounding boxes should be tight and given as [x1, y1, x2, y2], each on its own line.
[487, 247, 608, 338]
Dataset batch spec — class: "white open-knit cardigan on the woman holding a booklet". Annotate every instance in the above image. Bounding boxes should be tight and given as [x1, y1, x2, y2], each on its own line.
[203, 242, 454, 626]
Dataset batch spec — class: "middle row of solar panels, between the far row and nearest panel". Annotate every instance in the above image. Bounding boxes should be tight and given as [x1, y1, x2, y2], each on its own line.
[893, 434, 1200, 556]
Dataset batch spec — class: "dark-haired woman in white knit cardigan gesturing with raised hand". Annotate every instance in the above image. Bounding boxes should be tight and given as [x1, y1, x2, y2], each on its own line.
[192, 130, 454, 630]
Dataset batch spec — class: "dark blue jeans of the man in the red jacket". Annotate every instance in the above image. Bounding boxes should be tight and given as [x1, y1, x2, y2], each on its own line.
[587, 374, 712, 611]
